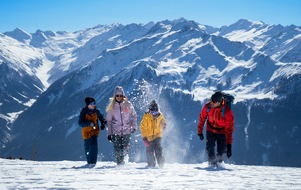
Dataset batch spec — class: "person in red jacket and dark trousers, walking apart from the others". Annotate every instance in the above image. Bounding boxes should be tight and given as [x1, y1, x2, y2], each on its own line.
[198, 91, 234, 165]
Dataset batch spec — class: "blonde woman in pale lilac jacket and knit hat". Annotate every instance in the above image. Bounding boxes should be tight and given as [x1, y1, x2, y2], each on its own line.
[106, 86, 137, 165]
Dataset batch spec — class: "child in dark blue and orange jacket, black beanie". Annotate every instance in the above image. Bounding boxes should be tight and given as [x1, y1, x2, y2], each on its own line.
[78, 97, 106, 165]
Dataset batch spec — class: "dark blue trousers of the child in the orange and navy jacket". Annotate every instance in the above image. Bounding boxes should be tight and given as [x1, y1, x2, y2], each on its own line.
[84, 136, 98, 164]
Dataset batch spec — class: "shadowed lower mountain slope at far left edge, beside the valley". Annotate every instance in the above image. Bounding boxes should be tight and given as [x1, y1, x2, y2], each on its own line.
[0, 62, 43, 145]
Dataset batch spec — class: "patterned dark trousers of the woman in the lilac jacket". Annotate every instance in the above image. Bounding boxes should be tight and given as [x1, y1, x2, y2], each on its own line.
[112, 134, 131, 165]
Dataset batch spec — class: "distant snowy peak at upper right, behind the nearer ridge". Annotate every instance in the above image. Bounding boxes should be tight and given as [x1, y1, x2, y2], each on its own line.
[215, 19, 301, 63]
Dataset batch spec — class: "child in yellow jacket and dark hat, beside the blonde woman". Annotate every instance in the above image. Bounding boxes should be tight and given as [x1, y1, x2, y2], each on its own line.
[140, 100, 166, 168]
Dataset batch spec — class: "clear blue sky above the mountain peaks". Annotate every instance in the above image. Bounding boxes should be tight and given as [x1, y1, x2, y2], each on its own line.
[0, 0, 301, 33]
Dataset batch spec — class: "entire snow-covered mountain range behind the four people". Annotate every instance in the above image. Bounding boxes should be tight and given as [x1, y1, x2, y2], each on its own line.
[0, 18, 301, 166]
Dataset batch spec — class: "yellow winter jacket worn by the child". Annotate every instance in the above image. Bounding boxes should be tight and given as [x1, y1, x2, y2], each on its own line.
[140, 112, 166, 141]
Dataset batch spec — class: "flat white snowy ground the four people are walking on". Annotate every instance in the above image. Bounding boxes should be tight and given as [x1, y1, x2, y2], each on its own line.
[0, 159, 301, 190]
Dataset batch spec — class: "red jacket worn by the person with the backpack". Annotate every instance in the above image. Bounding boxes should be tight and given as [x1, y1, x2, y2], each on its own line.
[198, 102, 234, 144]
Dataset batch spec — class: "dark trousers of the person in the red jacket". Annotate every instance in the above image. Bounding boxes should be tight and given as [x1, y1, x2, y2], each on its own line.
[206, 131, 226, 163]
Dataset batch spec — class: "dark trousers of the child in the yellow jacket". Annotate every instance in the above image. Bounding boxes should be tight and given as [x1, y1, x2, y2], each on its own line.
[146, 138, 164, 167]
